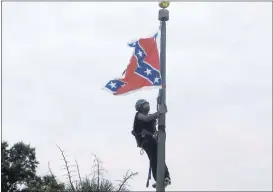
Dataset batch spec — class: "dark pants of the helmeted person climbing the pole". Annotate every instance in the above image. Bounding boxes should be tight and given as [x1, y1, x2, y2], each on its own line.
[143, 138, 170, 181]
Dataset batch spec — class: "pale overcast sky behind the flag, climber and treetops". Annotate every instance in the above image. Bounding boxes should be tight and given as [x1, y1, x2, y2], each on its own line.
[2, 2, 272, 190]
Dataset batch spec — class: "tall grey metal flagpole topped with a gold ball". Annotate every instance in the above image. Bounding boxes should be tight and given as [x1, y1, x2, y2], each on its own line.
[156, 1, 169, 192]
